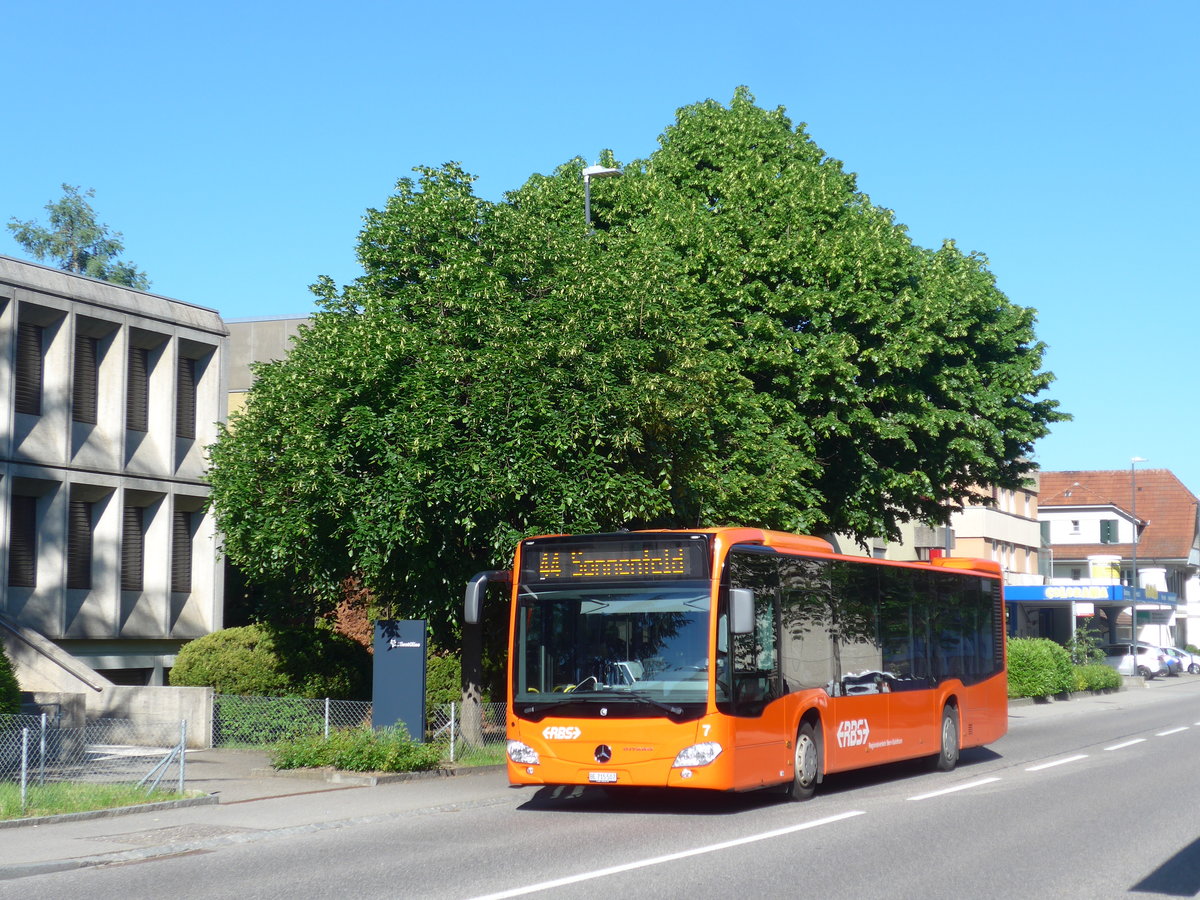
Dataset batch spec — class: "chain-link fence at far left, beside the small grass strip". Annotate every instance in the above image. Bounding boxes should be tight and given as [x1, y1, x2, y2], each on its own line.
[0, 714, 187, 818]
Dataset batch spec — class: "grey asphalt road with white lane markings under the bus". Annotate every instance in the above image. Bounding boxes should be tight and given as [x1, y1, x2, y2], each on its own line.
[9, 677, 1200, 900]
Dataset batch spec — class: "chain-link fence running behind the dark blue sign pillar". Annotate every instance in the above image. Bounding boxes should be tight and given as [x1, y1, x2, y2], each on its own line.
[212, 694, 505, 764]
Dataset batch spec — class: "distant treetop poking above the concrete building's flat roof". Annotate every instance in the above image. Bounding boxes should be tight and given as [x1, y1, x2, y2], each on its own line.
[8, 185, 150, 290]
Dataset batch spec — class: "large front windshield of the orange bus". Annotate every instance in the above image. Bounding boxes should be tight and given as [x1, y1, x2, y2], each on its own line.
[512, 582, 710, 715]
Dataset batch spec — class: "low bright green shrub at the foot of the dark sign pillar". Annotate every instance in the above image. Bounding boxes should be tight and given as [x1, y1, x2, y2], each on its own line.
[271, 725, 442, 772]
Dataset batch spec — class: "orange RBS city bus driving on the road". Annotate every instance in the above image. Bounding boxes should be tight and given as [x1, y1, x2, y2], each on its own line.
[464, 528, 1008, 799]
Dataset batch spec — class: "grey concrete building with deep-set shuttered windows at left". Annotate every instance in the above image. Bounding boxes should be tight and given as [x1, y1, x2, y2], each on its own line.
[0, 257, 227, 691]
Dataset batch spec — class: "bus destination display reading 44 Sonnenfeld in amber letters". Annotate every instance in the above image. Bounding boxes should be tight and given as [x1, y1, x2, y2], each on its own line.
[521, 535, 709, 584]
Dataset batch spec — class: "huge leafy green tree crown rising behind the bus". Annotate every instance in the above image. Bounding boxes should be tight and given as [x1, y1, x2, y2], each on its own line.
[211, 89, 1062, 646]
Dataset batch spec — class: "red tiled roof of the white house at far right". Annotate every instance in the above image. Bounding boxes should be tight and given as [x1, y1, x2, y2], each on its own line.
[1038, 469, 1200, 562]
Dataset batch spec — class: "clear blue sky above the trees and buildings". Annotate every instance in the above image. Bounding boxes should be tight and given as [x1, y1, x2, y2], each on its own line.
[0, 0, 1200, 494]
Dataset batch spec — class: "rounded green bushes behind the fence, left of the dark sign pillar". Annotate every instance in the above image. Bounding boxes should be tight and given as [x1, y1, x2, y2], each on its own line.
[170, 625, 371, 700]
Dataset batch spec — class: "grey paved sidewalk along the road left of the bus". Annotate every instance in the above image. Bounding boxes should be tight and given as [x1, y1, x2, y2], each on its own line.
[0, 750, 511, 881]
